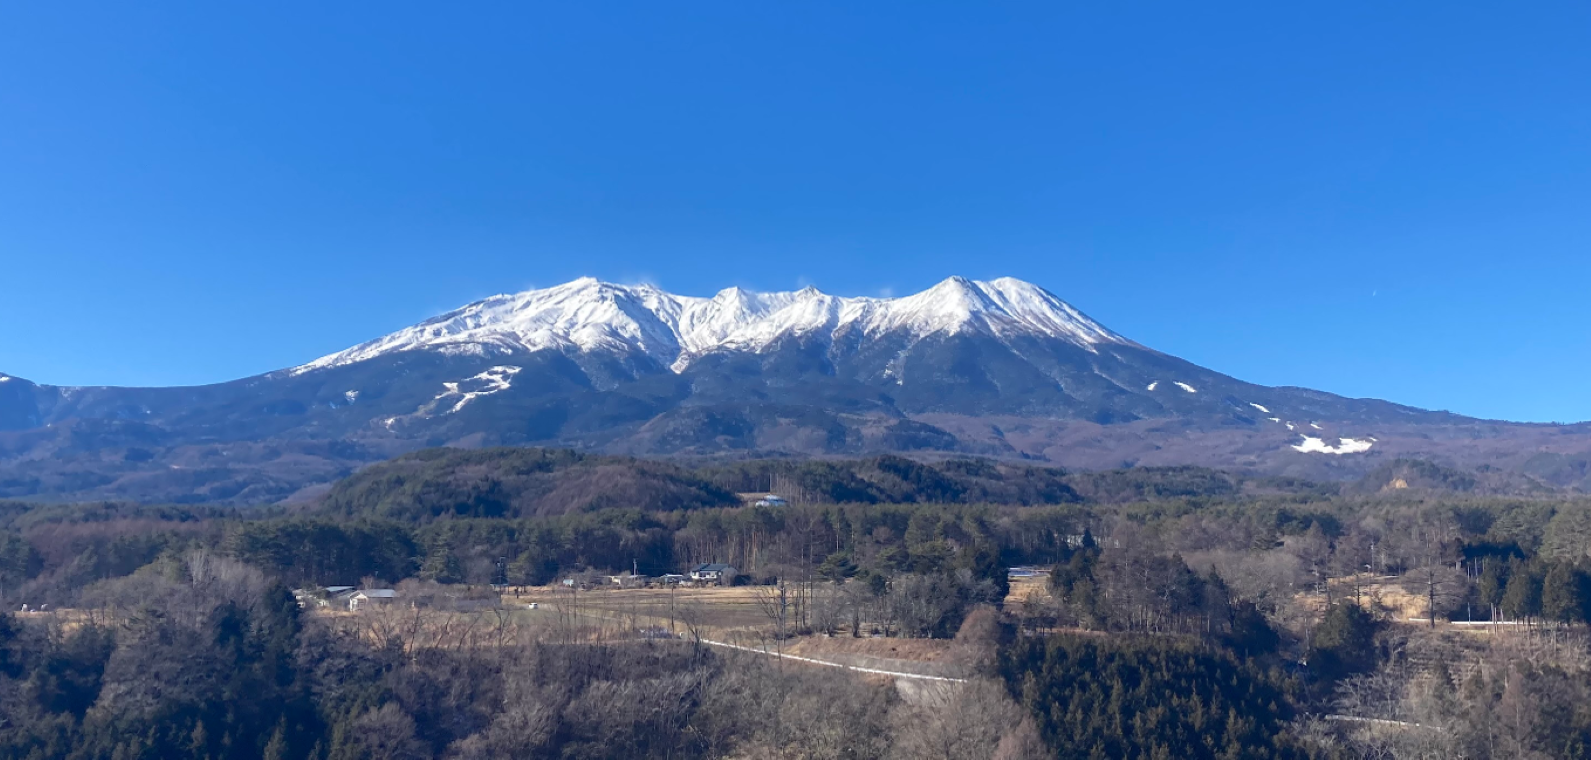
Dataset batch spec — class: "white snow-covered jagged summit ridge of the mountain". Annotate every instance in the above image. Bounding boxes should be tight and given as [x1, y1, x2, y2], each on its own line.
[291, 277, 1126, 375]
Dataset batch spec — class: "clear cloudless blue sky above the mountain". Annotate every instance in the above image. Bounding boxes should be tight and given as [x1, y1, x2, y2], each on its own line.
[0, 2, 1591, 421]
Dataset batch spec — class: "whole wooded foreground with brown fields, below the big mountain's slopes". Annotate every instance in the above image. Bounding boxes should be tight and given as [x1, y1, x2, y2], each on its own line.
[0, 450, 1591, 760]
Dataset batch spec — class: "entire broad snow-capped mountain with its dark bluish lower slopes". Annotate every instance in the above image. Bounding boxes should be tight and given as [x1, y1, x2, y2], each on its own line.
[0, 278, 1591, 501]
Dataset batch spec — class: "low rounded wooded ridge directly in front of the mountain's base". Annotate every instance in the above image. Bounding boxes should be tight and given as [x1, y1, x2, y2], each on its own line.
[309, 448, 1338, 522]
